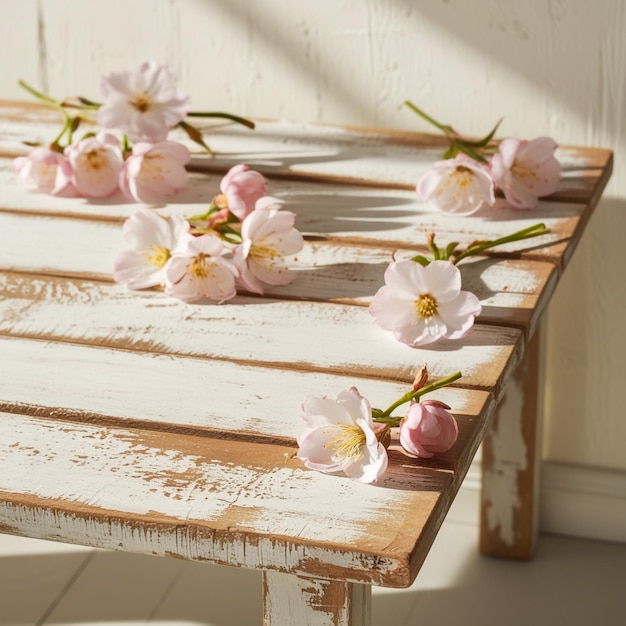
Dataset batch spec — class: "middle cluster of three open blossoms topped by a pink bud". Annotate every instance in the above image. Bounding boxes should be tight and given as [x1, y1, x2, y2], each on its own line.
[114, 165, 303, 302]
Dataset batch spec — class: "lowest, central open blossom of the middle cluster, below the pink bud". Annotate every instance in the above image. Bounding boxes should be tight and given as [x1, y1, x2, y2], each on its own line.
[165, 233, 239, 302]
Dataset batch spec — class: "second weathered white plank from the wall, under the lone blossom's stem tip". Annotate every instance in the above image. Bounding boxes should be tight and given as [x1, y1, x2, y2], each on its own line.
[0, 160, 604, 265]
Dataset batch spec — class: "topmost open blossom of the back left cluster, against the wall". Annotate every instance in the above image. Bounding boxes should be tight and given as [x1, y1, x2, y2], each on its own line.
[98, 61, 191, 142]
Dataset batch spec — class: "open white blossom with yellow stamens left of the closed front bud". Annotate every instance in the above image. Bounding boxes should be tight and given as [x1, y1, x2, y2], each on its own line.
[298, 387, 387, 483]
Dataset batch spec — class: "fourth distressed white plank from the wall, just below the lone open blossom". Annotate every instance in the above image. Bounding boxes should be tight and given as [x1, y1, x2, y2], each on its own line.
[0, 275, 521, 393]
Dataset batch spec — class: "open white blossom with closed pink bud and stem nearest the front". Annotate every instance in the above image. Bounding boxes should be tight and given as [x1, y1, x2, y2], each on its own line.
[297, 366, 461, 483]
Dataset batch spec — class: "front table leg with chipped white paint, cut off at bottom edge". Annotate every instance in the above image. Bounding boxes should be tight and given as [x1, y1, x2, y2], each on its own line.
[263, 571, 372, 626]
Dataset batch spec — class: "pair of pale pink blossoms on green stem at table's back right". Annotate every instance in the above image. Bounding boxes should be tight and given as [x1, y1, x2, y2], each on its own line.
[406, 102, 561, 215]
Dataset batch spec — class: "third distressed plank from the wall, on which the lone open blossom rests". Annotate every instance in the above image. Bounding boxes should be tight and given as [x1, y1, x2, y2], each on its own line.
[0, 206, 557, 327]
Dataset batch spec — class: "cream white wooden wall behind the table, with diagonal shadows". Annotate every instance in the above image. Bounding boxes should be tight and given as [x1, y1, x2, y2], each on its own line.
[0, 0, 626, 470]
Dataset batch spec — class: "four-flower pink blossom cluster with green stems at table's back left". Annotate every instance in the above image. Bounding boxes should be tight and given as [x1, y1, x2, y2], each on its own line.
[15, 62, 254, 204]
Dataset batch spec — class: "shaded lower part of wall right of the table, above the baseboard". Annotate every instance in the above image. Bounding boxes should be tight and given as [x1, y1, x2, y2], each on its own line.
[544, 197, 626, 470]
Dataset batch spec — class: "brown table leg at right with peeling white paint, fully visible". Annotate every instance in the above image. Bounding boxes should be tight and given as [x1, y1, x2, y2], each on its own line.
[480, 328, 543, 559]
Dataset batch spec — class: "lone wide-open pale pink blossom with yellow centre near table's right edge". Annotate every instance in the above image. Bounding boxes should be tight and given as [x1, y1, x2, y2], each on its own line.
[369, 260, 481, 347]
